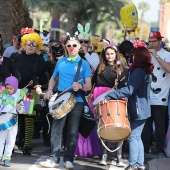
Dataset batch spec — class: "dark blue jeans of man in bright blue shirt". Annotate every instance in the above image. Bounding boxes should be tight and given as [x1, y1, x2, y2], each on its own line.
[49, 102, 84, 163]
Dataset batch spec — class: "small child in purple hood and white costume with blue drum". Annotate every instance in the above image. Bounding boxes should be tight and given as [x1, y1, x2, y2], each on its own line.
[0, 76, 25, 167]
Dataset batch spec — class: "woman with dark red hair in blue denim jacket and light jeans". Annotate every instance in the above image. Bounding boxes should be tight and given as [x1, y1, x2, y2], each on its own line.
[103, 41, 154, 170]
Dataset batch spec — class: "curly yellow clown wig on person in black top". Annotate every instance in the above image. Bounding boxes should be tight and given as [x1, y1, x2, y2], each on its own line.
[21, 33, 43, 51]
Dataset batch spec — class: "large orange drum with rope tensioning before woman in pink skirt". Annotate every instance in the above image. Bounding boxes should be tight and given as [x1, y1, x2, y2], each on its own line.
[97, 100, 131, 141]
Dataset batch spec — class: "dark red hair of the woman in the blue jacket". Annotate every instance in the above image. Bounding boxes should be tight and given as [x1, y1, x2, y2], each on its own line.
[133, 47, 154, 74]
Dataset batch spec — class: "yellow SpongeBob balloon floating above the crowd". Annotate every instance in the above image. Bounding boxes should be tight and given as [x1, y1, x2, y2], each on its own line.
[120, 4, 138, 34]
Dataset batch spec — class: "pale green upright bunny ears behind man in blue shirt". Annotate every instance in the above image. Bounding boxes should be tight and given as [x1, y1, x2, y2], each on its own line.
[77, 23, 90, 40]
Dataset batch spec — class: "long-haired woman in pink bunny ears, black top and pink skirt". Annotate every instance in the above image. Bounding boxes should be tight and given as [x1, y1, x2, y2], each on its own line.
[89, 40, 128, 166]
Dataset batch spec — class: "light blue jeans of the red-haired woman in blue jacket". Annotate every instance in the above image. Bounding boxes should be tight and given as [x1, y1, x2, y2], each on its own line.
[129, 120, 146, 167]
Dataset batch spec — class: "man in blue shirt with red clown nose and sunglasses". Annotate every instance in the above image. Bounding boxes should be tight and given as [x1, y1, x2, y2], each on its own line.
[39, 32, 91, 169]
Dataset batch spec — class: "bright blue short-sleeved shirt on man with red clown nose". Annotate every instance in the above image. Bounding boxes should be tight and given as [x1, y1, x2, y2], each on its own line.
[53, 56, 92, 102]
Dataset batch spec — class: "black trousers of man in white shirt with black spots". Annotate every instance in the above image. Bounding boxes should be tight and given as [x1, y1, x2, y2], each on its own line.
[142, 105, 167, 153]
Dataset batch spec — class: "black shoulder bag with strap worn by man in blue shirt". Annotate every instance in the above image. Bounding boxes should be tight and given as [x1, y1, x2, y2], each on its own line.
[75, 59, 96, 138]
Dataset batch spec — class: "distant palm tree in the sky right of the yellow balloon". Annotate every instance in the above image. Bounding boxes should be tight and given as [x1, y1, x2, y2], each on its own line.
[138, 2, 150, 40]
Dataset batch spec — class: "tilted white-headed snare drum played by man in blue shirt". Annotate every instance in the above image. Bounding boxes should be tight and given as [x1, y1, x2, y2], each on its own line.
[48, 92, 76, 119]
